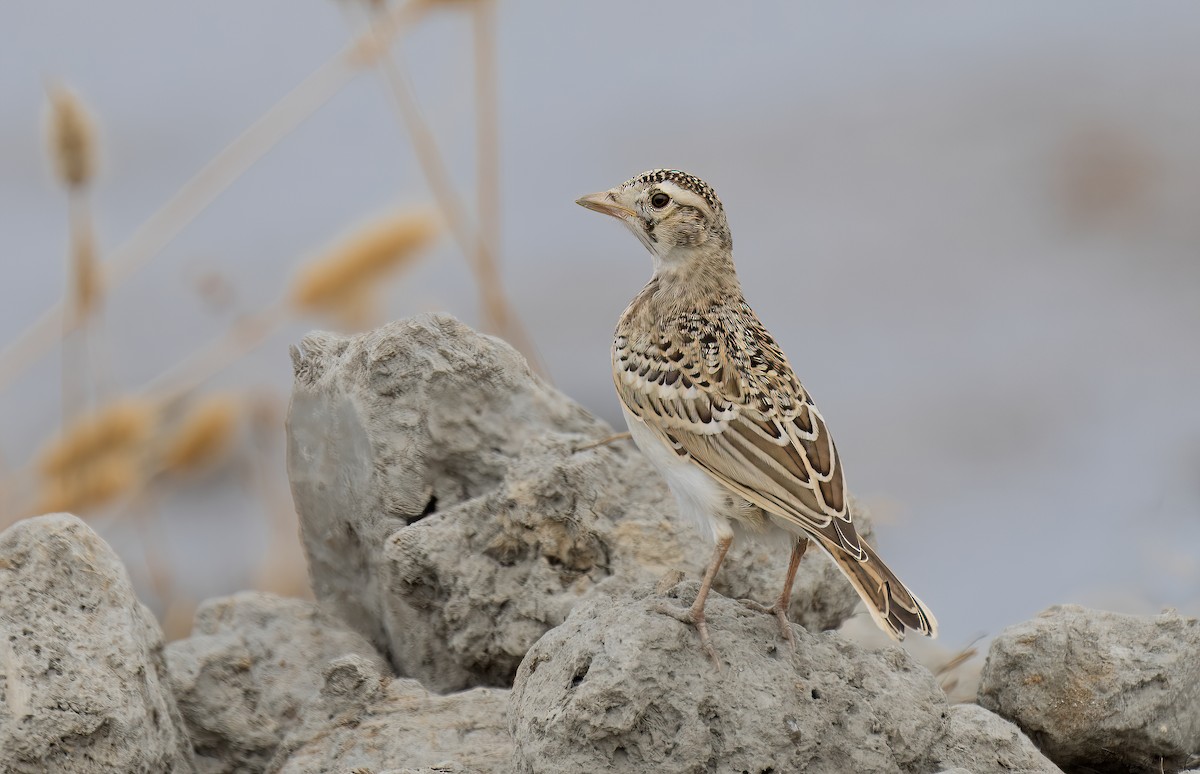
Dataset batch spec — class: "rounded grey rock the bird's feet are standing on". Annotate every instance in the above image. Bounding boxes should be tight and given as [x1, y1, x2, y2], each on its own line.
[509, 582, 952, 774]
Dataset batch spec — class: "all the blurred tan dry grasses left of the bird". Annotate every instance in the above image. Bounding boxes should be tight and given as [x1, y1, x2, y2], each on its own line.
[0, 0, 525, 637]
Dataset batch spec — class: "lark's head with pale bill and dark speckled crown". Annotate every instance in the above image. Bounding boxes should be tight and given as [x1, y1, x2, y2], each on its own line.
[576, 169, 733, 270]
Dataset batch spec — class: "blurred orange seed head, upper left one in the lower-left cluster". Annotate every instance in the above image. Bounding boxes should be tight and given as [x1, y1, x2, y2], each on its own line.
[37, 398, 158, 476]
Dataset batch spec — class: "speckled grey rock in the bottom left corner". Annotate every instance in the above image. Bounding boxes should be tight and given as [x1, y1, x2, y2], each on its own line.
[0, 514, 194, 774]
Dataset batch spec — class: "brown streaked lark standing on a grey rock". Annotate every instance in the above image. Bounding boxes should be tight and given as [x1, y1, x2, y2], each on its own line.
[578, 169, 937, 670]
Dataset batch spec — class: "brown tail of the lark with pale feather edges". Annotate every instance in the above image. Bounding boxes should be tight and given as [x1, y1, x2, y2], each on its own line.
[815, 535, 937, 640]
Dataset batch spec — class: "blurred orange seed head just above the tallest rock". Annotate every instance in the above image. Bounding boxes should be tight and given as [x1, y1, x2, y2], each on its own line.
[290, 211, 439, 312]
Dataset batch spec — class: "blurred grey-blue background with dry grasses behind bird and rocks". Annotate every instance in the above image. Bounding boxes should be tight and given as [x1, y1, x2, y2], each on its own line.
[0, 0, 1200, 648]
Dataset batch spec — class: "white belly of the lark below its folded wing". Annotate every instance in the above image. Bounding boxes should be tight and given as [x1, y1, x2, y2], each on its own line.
[622, 407, 736, 542]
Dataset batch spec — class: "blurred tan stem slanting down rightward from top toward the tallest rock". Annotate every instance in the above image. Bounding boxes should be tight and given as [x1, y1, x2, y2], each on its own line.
[355, 3, 546, 376]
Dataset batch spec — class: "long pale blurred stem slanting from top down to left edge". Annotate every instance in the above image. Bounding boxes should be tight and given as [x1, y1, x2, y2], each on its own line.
[0, 0, 431, 390]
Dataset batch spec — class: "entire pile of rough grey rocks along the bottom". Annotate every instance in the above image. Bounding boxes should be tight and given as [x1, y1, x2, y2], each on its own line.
[0, 316, 1200, 774]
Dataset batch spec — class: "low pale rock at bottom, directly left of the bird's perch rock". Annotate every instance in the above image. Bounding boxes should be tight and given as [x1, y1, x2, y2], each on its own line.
[266, 655, 512, 774]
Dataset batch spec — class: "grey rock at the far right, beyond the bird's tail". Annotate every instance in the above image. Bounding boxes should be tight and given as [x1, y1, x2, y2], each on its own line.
[979, 605, 1200, 772]
